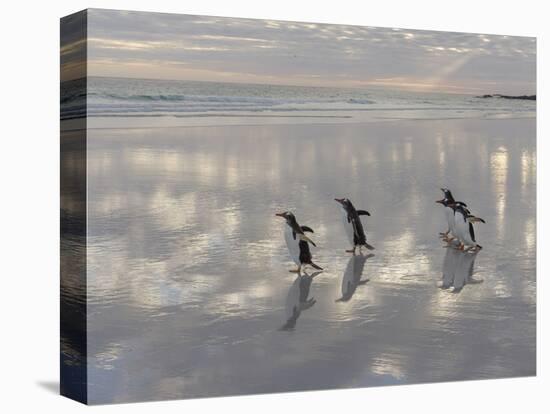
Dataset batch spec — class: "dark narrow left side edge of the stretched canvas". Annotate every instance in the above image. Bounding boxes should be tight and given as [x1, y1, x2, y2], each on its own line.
[60, 11, 88, 403]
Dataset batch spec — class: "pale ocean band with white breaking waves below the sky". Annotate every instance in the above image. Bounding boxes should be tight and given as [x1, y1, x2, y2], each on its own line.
[61, 77, 536, 126]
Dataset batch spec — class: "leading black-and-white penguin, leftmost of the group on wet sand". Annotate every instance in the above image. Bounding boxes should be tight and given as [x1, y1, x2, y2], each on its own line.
[275, 211, 323, 273]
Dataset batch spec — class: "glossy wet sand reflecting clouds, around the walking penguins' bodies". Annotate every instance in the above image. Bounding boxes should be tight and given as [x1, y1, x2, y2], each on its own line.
[78, 120, 536, 403]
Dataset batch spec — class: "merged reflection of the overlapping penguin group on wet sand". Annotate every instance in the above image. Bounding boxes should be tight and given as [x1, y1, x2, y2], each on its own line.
[439, 249, 483, 293]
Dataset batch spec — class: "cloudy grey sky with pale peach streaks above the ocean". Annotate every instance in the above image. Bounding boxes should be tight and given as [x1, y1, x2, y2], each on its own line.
[62, 9, 536, 94]
